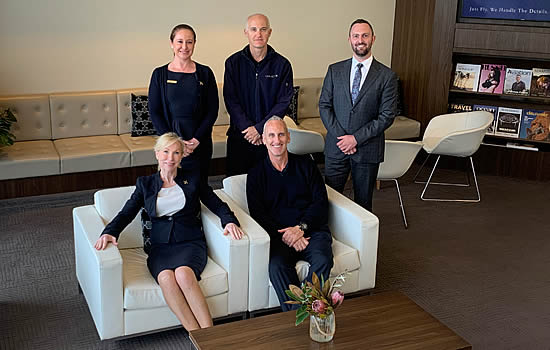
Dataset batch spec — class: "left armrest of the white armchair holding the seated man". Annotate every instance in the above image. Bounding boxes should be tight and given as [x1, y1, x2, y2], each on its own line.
[214, 190, 269, 311]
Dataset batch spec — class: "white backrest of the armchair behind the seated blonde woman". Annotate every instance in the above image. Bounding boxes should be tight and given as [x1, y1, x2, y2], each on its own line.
[94, 186, 143, 249]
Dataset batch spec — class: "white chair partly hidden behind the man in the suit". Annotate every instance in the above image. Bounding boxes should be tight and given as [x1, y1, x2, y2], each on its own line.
[376, 140, 422, 228]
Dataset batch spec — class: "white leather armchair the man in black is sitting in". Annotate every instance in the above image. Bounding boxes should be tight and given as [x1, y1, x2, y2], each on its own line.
[217, 175, 378, 312]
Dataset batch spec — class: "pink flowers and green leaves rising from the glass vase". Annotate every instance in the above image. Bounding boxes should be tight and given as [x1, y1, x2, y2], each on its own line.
[285, 272, 347, 325]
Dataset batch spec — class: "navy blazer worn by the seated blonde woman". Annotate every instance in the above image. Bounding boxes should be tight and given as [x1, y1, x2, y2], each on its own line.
[101, 169, 239, 244]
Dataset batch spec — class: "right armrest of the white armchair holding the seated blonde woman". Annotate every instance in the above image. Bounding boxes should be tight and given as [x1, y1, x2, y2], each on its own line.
[201, 204, 248, 314]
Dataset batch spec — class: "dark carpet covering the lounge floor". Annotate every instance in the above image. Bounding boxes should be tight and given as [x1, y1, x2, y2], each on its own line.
[0, 172, 550, 349]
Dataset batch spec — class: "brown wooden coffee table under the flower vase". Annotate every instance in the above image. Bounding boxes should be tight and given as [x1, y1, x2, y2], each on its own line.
[190, 292, 472, 350]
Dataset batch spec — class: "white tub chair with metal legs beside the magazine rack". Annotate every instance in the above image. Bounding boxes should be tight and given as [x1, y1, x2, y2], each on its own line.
[415, 111, 493, 202]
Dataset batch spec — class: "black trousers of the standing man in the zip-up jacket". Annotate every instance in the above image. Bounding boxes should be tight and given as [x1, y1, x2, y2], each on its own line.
[226, 134, 267, 176]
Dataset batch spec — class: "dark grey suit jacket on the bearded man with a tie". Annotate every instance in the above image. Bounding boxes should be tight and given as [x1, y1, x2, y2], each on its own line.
[319, 58, 397, 163]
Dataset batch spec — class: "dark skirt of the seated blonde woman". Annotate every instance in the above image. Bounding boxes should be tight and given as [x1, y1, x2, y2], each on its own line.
[147, 239, 207, 283]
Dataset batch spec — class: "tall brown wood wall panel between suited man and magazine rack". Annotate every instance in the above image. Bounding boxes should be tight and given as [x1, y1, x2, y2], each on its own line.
[392, 0, 458, 130]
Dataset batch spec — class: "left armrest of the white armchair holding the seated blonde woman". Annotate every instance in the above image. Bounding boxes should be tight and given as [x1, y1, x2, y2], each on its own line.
[73, 205, 124, 339]
